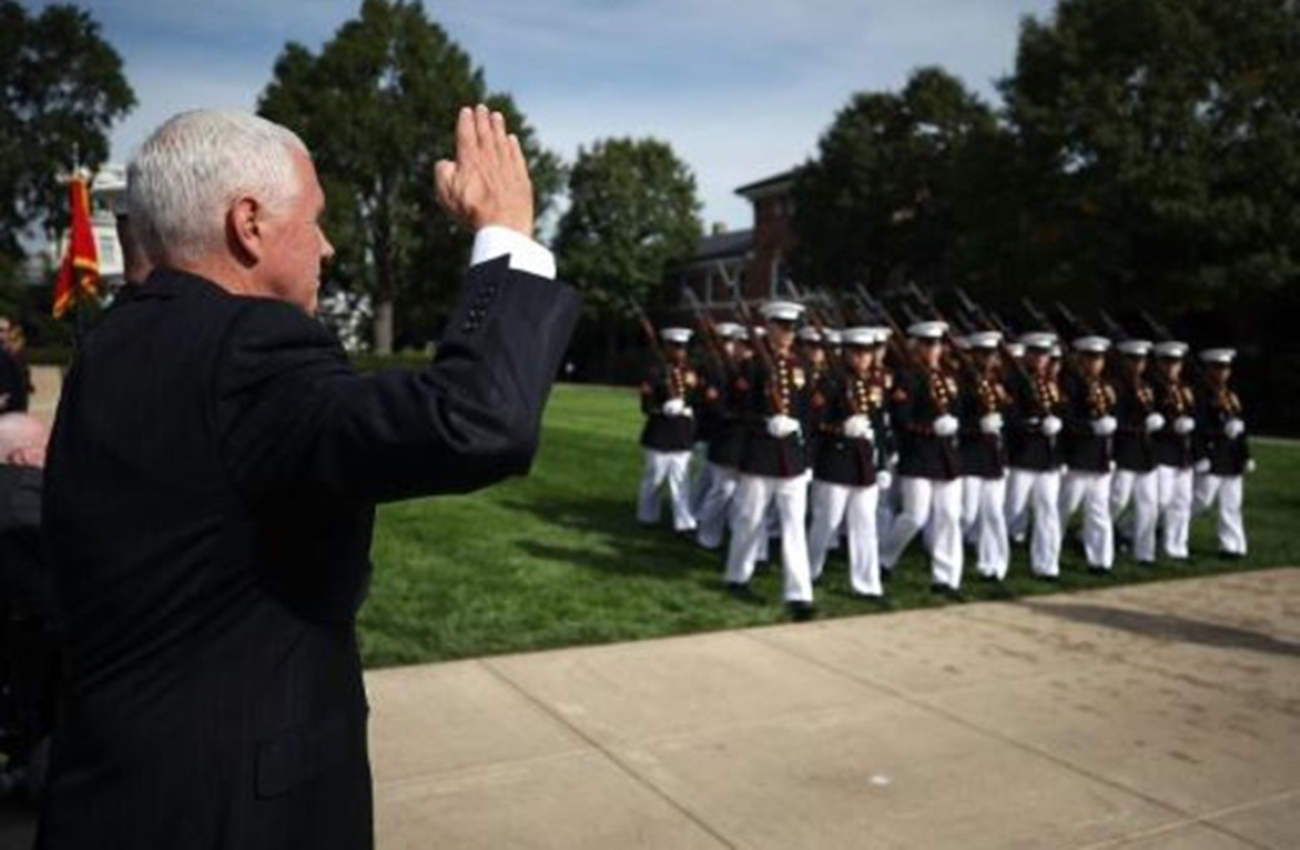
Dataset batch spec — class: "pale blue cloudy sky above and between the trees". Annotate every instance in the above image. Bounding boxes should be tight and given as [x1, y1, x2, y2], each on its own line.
[63, 0, 1054, 227]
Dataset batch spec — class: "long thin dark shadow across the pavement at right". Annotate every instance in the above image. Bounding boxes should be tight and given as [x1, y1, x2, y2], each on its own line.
[1022, 602, 1300, 658]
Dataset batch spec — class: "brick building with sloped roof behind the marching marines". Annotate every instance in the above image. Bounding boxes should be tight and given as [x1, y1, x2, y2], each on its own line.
[670, 169, 796, 311]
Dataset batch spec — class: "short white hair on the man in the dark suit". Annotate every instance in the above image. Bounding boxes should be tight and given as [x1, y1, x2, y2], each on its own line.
[126, 109, 308, 264]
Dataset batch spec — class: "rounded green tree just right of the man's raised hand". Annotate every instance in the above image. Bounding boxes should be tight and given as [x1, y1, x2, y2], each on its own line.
[555, 139, 702, 316]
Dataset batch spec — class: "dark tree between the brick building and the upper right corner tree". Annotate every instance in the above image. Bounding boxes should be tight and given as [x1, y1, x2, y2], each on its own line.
[792, 68, 1005, 300]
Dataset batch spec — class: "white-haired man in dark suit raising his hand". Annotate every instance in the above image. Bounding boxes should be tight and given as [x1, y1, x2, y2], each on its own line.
[38, 107, 579, 850]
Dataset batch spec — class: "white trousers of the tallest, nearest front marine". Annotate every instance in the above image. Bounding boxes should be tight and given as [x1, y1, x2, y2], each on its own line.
[727, 473, 813, 602]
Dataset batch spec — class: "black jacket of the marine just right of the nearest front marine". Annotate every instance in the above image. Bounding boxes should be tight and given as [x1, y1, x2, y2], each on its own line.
[813, 374, 884, 487]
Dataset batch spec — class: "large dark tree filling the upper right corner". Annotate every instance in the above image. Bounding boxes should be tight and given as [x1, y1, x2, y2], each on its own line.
[1002, 0, 1300, 311]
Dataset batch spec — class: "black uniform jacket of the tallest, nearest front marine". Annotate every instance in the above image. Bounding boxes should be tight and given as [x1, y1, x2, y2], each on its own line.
[740, 354, 813, 478]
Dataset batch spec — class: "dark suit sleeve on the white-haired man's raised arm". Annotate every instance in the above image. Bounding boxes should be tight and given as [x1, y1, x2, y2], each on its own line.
[213, 257, 580, 506]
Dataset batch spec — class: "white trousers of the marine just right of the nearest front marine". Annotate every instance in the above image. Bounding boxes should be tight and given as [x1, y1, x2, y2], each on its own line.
[809, 481, 884, 597]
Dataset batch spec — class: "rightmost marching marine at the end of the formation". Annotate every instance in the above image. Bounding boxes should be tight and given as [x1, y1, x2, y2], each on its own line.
[1192, 348, 1255, 560]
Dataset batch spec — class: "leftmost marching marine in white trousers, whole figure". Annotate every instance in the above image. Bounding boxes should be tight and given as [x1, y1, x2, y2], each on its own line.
[637, 328, 702, 533]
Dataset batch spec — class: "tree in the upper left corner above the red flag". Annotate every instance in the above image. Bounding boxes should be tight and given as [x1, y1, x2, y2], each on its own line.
[0, 0, 135, 262]
